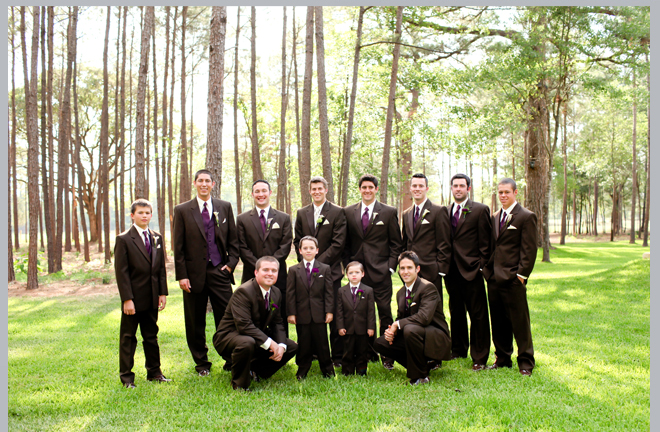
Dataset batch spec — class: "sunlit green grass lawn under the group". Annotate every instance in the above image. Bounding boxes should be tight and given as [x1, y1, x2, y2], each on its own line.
[8, 242, 650, 431]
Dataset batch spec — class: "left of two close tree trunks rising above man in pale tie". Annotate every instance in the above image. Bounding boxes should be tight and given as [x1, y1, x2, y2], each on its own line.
[298, 6, 314, 206]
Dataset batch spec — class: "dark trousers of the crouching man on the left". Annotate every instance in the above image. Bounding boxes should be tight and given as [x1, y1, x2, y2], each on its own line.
[218, 332, 298, 388]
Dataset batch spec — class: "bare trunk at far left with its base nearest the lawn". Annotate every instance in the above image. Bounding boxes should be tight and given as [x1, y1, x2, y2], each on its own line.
[21, 6, 39, 289]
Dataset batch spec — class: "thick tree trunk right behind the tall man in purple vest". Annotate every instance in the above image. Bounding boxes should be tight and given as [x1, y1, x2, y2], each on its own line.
[206, 6, 227, 198]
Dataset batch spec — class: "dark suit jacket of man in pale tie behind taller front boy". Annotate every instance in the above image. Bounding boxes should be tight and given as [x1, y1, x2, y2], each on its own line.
[293, 201, 346, 281]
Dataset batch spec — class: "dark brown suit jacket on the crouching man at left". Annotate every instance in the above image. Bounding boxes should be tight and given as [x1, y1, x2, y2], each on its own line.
[213, 278, 286, 352]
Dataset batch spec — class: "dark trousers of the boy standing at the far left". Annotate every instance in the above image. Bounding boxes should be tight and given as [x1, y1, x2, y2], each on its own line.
[119, 309, 163, 383]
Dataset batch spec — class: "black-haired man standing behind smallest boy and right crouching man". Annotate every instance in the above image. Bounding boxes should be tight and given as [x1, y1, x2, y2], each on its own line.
[343, 174, 403, 369]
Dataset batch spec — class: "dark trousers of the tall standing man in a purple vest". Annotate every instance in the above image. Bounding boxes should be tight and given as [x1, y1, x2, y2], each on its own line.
[183, 262, 232, 372]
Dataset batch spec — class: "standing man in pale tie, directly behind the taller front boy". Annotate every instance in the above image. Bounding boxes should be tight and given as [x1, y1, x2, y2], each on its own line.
[293, 176, 346, 366]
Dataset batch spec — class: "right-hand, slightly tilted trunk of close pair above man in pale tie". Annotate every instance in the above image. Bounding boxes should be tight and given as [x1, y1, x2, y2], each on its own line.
[314, 6, 335, 201]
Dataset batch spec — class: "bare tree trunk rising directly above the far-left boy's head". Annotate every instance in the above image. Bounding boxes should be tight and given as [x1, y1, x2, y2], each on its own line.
[135, 6, 154, 198]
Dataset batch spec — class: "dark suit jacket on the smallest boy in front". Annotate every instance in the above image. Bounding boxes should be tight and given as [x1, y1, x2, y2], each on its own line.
[335, 283, 376, 335]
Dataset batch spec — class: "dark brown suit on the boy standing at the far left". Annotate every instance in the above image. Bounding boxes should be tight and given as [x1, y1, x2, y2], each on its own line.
[114, 226, 168, 383]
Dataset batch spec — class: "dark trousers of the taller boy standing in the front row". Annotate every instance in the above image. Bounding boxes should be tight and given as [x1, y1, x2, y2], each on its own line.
[296, 323, 335, 378]
